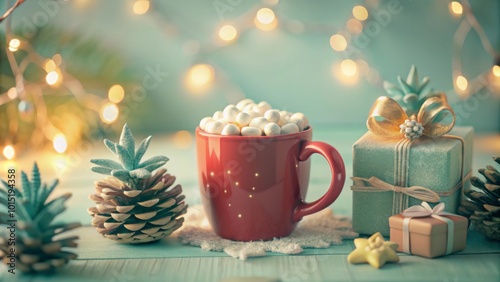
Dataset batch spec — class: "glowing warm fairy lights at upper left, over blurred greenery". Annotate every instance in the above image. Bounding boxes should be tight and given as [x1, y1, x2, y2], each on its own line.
[0, 0, 129, 160]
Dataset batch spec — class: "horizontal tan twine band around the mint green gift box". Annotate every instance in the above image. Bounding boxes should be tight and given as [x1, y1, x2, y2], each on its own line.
[351, 176, 440, 203]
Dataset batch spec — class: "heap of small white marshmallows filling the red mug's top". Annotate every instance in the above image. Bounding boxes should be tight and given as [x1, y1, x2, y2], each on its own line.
[200, 99, 309, 136]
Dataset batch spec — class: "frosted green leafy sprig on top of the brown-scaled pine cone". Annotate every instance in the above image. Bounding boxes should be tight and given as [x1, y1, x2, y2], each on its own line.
[90, 124, 168, 187]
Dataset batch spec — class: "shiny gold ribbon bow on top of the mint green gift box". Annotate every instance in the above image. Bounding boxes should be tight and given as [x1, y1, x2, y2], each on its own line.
[366, 94, 455, 138]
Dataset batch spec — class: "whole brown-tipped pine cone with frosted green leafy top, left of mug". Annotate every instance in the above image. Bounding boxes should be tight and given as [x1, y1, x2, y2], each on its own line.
[88, 124, 187, 243]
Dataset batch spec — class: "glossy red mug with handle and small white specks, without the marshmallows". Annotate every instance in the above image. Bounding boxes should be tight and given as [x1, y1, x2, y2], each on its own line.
[196, 128, 345, 241]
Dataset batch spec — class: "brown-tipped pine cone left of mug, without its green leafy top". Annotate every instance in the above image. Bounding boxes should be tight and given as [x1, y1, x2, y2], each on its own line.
[88, 169, 187, 243]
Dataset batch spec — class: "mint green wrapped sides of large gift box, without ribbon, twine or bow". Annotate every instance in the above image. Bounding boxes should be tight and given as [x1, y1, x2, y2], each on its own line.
[352, 127, 474, 236]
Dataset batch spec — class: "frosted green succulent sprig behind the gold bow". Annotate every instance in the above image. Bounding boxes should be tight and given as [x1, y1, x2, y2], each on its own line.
[384, 66, 433, 116]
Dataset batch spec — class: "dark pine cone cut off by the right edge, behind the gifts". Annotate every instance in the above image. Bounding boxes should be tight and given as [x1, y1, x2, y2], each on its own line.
[458, 157, 500, 240]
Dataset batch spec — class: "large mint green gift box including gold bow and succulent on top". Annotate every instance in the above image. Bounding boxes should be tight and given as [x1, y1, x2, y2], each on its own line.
[351, 67, 473, 236]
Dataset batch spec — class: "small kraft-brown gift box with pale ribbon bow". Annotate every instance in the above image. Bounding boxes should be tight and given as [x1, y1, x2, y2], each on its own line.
[389, 202, 468, 258]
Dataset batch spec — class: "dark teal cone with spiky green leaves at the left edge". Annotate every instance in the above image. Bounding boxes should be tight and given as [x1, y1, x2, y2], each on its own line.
[0, 163, 81, 272]
